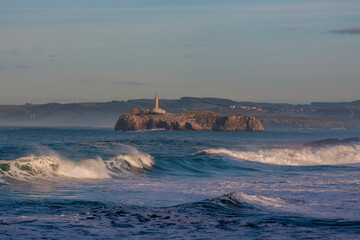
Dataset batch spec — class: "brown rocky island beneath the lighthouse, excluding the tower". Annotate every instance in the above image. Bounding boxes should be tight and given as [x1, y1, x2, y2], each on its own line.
[115, 108, 264, 132]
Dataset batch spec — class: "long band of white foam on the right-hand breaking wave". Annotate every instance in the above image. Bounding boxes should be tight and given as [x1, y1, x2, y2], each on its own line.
[202, 144, 360, 166]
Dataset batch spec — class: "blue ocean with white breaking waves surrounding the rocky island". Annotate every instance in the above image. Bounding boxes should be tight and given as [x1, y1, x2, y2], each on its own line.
[0, 127, 360, 239]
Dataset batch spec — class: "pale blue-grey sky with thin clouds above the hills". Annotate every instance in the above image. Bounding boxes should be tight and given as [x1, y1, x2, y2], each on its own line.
[0, 0, 360, 105]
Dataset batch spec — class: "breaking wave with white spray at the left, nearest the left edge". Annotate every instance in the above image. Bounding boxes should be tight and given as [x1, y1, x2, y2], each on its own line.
[0, 149, 154, 184]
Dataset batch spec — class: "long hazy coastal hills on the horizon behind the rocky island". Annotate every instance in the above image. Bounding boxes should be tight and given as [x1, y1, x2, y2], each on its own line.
[0, 97, 360, 129]
